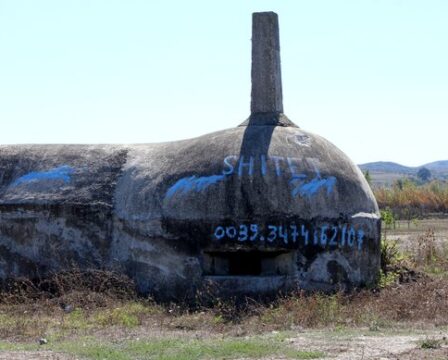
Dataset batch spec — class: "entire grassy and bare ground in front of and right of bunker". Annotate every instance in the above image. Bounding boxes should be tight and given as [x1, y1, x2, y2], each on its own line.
[0, 219, 448, 359]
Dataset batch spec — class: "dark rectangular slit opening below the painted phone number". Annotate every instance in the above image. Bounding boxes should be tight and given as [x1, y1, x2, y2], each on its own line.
[203, 251, 295, 276]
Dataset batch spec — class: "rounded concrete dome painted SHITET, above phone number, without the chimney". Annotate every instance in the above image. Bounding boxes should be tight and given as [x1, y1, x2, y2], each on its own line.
[126, 121, 378, 221]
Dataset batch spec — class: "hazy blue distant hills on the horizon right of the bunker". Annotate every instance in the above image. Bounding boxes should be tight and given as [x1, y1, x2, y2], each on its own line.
[359, 160, 448, 187]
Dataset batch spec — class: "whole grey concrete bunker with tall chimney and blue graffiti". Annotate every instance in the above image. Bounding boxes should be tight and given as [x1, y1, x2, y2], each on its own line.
[0, 12, 380, 299]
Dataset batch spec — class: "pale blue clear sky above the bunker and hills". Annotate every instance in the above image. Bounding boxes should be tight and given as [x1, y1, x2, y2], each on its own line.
[0, 0, 448, 166]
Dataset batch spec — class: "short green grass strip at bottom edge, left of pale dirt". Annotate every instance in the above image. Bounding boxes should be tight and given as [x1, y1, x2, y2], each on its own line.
[0, 336, 324, 360]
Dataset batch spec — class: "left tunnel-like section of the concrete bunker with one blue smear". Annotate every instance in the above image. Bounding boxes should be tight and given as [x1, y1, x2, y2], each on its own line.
[0, 145, 127, 278]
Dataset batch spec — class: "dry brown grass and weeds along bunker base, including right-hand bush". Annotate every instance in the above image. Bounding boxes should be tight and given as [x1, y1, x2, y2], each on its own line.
[0, 221, 448, 341]
